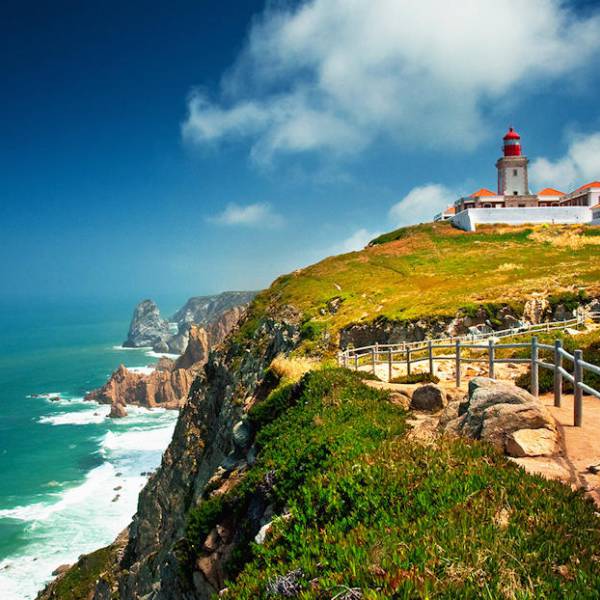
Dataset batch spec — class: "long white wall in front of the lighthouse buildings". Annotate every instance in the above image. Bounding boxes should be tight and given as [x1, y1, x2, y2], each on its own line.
[451, 206, 592, 231]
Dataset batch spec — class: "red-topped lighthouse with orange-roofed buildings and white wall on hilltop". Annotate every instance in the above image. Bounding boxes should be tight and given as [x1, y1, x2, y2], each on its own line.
[434, 127, 600, 231]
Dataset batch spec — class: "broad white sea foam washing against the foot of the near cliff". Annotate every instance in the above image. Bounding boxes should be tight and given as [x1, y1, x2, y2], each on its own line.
[0, 405, 177, 600]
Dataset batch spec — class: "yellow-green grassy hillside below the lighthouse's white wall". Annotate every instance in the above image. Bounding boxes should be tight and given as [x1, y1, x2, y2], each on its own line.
[241, 223, 600, 346]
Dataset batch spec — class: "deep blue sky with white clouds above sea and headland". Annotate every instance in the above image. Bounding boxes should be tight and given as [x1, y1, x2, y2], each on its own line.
[0, 0, 600, 299]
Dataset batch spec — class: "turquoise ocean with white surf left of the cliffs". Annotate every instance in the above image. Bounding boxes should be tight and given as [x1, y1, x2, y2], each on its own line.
[0, 301, 177, 600]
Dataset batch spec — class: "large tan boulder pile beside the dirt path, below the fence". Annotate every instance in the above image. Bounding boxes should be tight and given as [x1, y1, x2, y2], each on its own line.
[440, 377, 558, 457]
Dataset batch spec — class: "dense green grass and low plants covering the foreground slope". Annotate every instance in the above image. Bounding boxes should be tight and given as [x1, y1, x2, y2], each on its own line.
[182, 369, 600, 600]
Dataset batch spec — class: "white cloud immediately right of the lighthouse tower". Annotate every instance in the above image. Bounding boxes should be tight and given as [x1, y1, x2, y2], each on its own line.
[529, 132, 600, 192]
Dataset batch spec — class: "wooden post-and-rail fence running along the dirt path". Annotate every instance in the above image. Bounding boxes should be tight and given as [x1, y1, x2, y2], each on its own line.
[338, 311, 600, 427]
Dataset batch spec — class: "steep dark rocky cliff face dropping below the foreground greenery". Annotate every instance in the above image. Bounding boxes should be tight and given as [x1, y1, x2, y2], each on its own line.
[113, 311, 299, 600]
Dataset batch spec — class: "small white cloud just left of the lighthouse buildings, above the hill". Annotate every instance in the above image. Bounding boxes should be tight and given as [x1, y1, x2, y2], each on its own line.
[389, 183, 457, 227]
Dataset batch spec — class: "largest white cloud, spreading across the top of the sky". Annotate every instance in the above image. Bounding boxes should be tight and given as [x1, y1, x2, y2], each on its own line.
[182, 0, 600, 163]
